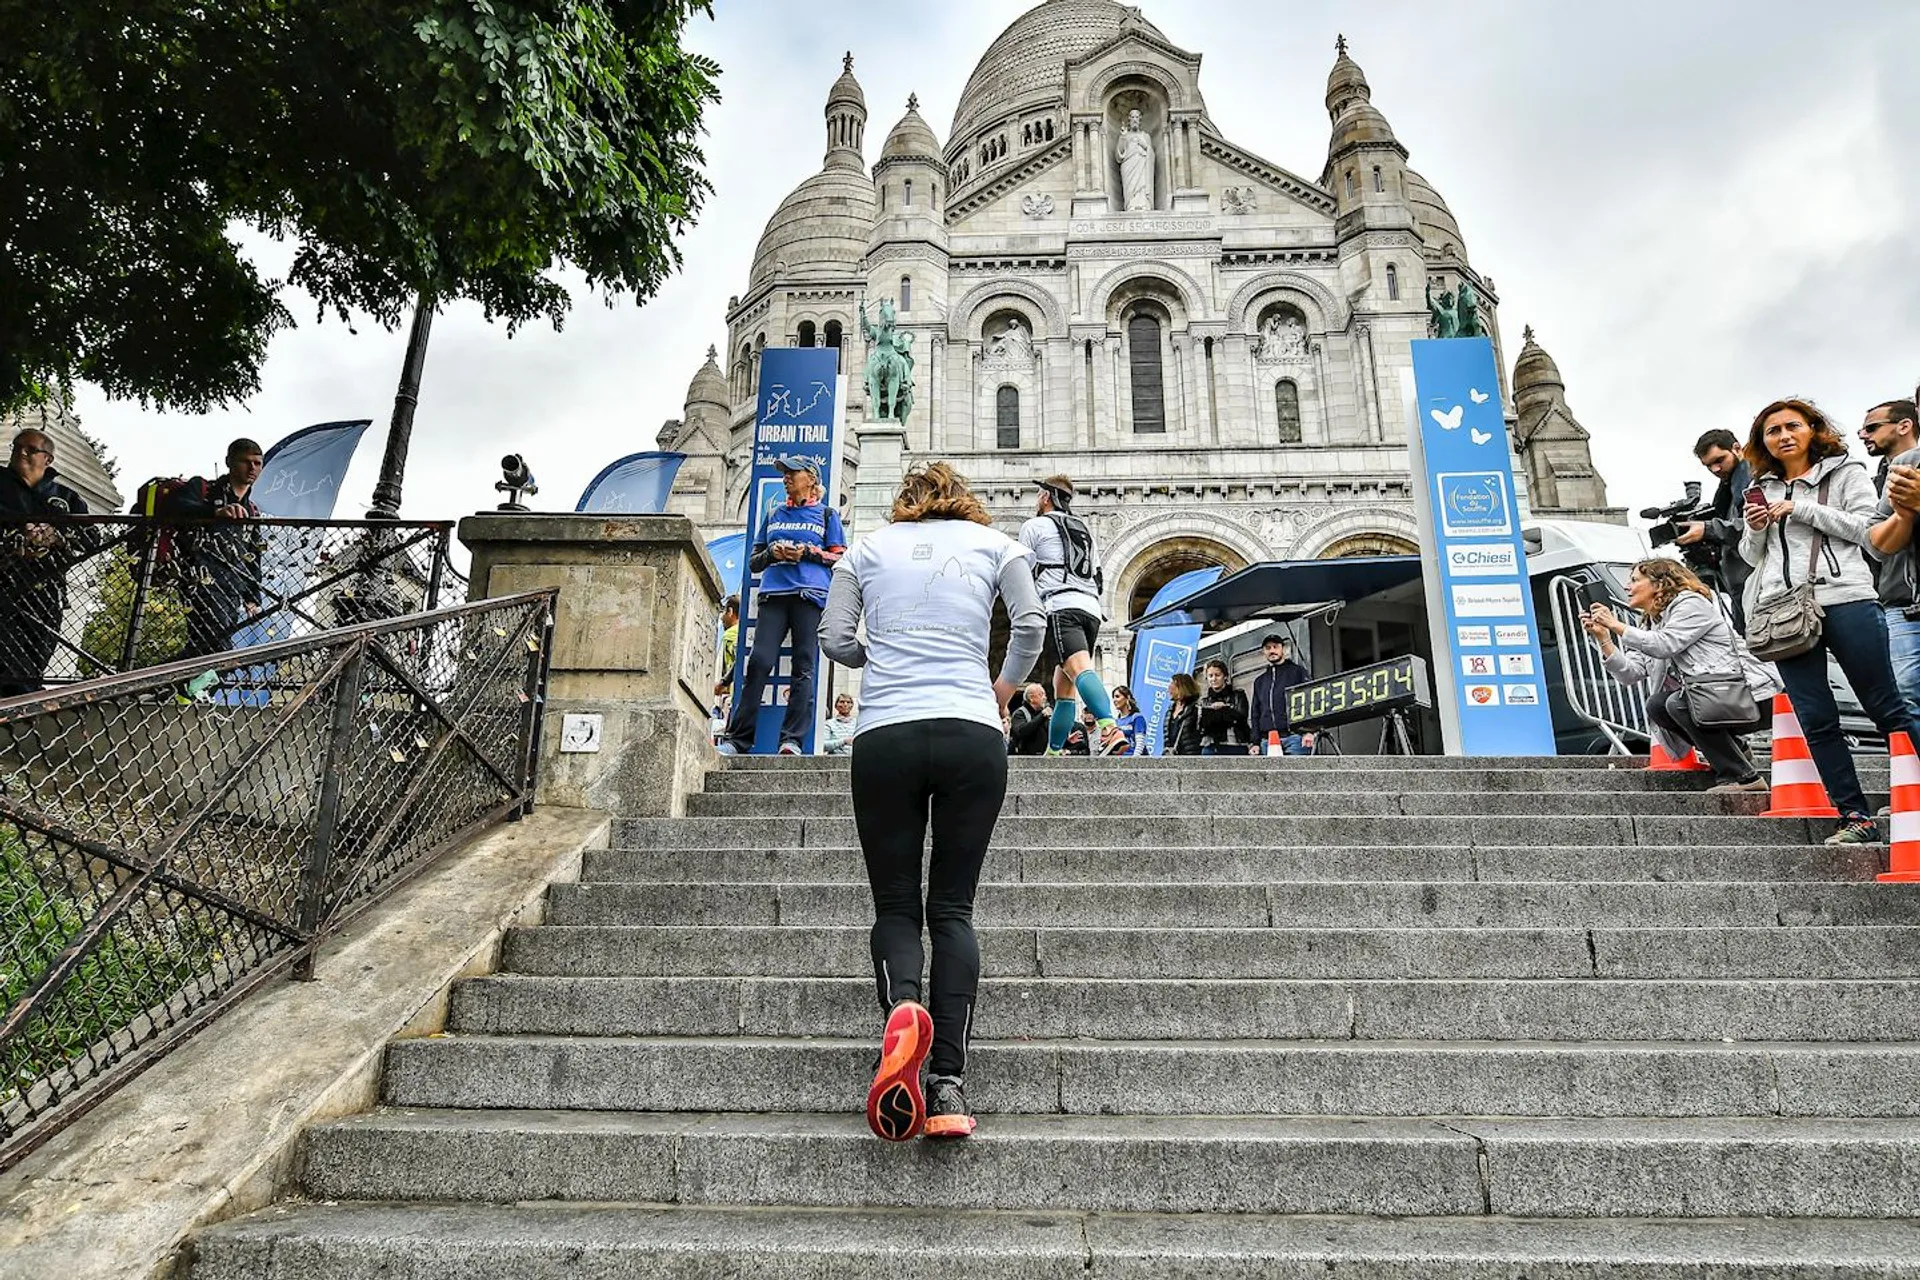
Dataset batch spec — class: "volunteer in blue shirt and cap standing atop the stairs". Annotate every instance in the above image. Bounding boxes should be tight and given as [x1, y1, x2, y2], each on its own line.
[716, 457, 847, 756]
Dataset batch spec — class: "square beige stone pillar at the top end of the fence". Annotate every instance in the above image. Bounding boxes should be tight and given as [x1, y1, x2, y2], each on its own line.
[459, 512, 726, 818]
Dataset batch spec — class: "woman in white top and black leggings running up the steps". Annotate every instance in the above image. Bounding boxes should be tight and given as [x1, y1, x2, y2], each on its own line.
[820, 462, 1046, 1142]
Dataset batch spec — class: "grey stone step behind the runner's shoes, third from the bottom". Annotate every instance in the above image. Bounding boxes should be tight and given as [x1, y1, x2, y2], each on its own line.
[384, 1036, 1920, 1117]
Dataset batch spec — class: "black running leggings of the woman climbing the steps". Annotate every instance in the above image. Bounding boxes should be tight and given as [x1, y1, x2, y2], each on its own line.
[852, 720, 1006, 1077]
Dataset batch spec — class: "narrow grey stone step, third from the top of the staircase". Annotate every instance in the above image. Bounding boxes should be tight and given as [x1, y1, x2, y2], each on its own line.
[687, 787, 1766, 829]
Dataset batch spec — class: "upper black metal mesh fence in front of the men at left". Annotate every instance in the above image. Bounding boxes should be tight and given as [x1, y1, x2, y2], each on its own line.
[0, 516, 465, 697]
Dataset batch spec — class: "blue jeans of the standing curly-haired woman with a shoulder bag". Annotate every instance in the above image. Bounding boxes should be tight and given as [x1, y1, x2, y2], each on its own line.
[1776, 601, 1914, 818]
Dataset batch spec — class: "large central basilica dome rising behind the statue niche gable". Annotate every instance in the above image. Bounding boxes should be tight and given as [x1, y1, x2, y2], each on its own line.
[947, 0, 1165, 142]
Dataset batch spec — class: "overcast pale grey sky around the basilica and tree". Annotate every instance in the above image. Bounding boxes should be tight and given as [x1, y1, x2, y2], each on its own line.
[77, 0, 1920, 518]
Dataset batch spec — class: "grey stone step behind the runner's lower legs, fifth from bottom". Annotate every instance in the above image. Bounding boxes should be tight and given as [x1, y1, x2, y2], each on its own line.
[501, 925, 1920, 979]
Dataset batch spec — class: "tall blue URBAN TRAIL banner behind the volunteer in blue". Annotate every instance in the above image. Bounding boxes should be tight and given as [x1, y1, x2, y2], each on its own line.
[733, 347, 841, 754]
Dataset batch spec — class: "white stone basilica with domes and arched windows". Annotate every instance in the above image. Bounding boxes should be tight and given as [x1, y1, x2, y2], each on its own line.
[660, 0, 1619, 624]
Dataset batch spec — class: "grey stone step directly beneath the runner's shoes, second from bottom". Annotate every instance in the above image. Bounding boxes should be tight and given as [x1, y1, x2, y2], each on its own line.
[301, 1111, 1920, 1219]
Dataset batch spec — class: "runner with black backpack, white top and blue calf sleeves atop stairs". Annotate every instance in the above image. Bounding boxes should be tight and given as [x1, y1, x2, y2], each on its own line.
[1020, 476, 1127, 756]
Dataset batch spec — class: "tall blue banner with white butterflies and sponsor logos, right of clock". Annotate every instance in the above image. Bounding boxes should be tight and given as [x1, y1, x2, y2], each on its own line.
[1409, 338, 1555, 756]
